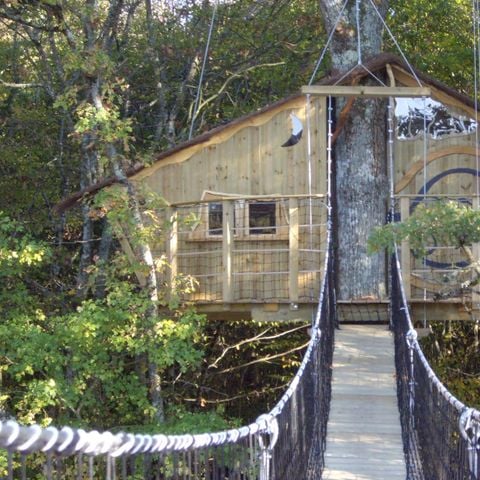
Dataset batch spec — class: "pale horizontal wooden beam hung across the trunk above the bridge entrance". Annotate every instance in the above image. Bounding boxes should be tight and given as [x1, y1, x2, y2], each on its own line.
[302, 85, 431, 97]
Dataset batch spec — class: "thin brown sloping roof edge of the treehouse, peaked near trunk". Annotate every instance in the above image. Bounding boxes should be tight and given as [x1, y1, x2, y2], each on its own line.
[56, 53, 475, 212]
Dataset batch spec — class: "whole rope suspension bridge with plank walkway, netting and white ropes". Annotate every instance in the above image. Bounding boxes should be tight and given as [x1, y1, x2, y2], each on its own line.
[4, 0, 480, 480]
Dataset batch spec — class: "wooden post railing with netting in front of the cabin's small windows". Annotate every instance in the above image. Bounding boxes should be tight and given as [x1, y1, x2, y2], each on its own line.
[163, 195, 327, 304]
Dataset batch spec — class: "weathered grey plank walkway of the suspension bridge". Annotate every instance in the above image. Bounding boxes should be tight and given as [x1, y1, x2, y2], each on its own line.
[322, 325, 406, 480]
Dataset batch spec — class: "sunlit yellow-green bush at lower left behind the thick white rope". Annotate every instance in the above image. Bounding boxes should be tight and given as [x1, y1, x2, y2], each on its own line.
[0, 251, 203, 428]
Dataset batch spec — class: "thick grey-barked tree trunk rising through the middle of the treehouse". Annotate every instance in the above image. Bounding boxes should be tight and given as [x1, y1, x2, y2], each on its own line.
[321, 0, 388, 300]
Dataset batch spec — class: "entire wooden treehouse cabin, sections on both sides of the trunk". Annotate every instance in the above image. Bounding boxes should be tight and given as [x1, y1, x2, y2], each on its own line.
[107, 54, 478, 320]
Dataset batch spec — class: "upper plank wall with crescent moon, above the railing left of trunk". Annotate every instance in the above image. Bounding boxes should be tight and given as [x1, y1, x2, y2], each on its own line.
[141, 97, 326, 203]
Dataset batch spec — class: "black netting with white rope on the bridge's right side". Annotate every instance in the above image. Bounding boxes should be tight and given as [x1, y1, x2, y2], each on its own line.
[391, 251, 480, 480]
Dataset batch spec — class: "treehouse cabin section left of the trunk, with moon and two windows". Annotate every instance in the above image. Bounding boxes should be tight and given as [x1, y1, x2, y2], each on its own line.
[133, 95, 327, 320]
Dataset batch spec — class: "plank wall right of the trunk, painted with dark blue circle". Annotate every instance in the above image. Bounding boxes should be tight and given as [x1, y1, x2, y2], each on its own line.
[395, 129, 478, 299]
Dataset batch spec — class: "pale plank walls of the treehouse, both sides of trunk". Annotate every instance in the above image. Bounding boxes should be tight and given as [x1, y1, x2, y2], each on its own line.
[139, 86, 477, 310]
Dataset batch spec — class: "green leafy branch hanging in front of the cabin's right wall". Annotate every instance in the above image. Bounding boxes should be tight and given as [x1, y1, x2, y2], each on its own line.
[368, 201, 480, 255]
